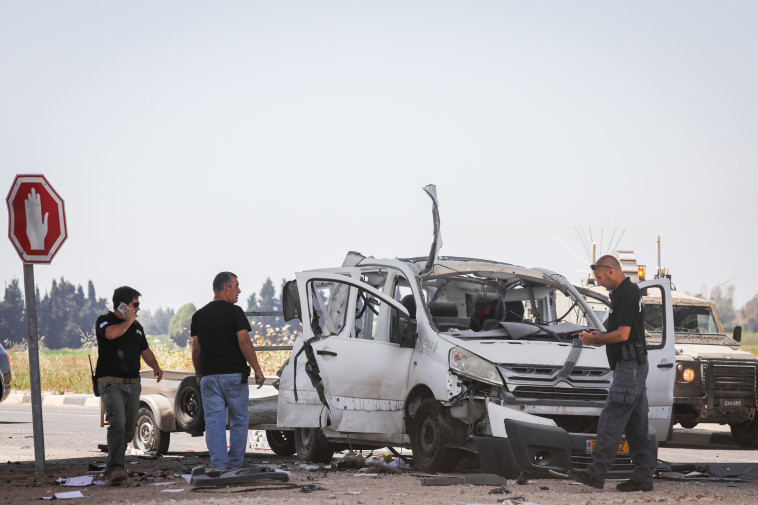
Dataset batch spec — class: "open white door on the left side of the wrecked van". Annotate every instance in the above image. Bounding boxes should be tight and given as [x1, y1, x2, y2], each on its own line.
[280, 271, 415, 434]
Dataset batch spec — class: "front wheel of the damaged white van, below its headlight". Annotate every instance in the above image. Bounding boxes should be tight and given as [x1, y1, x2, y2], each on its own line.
[410, 398, 461, 472]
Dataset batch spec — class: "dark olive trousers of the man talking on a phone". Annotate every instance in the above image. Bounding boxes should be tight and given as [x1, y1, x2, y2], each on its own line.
[97, 381, 142, 475]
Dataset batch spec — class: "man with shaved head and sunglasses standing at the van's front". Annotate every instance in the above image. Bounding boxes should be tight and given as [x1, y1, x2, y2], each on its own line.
[568, 255, 656, 491]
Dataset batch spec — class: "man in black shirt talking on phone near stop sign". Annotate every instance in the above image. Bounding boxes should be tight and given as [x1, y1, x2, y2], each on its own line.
[95, 286, 163, 486]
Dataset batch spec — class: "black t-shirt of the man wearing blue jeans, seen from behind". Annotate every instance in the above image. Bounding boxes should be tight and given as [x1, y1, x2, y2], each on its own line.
[190, 300, 252, 376]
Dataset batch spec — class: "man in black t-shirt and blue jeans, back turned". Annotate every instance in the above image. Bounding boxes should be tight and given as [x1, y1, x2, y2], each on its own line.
[190, 272, 264, 470]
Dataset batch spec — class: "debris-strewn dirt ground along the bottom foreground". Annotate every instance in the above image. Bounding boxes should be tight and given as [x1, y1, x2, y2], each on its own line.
[0, 446, 758, 505]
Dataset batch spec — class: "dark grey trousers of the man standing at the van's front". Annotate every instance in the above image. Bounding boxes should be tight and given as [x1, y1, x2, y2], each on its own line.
[587, 360, 656, 484]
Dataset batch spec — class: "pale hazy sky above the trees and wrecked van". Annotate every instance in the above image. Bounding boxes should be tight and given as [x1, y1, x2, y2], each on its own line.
[0, 0, 758, 309]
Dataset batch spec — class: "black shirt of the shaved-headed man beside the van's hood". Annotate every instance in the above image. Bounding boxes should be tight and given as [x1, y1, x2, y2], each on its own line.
[605, 277, 645, 369]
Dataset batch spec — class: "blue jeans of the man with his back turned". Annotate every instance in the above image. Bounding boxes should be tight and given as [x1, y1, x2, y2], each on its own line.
[200, 373, 250, 470]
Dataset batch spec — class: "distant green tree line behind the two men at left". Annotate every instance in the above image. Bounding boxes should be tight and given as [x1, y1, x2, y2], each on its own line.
[0, 277, 284, 349]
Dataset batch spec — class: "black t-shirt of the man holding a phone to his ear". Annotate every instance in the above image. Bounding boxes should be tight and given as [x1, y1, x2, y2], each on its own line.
[95, 312, 149, 379]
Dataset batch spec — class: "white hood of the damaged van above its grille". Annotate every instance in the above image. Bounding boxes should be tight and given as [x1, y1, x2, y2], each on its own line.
[454, 339, 609, 368]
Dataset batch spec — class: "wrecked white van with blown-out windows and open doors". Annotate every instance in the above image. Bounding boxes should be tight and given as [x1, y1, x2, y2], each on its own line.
[277, 186, 674, 476]
